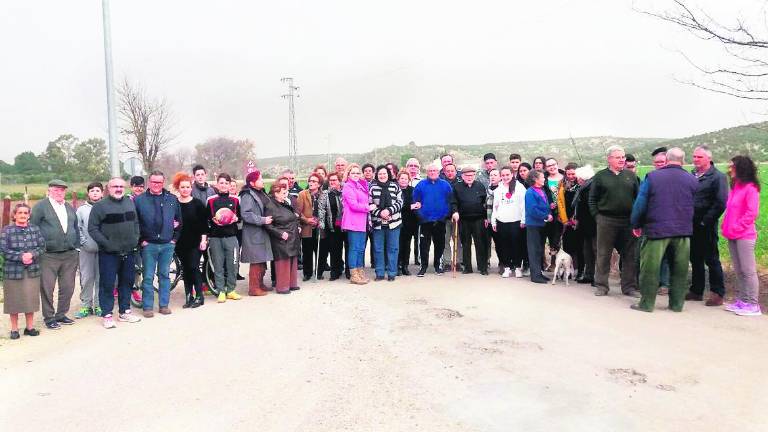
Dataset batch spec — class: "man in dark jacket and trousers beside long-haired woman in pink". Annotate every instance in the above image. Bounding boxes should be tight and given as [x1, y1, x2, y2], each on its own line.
[685, 145, 728, 306]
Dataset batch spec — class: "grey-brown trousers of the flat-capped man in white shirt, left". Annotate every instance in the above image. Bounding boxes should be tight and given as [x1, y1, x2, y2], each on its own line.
[40, 250, 80, 322]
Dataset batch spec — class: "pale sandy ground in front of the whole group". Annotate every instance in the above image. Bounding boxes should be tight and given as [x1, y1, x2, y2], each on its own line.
[0, 264, 768, 432]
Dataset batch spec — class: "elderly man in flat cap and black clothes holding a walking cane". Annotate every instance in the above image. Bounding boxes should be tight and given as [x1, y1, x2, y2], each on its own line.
[451, 166, 488, 275]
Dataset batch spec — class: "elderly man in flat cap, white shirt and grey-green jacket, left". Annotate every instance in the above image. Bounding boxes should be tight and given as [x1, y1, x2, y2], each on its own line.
[30, 180, 80, 330]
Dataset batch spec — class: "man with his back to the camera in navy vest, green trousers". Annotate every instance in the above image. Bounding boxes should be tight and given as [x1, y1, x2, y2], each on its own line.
[624, 147, 698, 312]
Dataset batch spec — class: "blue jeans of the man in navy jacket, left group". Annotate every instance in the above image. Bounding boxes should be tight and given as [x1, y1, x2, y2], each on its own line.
[141, 243, 175, 310]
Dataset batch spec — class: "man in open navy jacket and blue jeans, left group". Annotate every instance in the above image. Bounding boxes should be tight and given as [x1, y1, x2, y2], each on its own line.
[134, 171, 181, 318]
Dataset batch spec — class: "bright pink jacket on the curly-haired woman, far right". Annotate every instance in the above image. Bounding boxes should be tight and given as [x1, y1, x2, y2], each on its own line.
[722, 181, 760, 240]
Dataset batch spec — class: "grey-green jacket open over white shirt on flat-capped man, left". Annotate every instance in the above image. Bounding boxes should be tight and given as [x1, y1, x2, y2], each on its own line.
[29, 198, 80, 252]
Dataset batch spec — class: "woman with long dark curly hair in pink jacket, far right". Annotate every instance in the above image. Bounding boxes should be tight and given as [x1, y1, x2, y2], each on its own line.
[722, 156, 762, 316]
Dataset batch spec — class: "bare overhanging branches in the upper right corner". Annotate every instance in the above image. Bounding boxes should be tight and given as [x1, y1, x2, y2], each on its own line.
[640, 0, 768, 100]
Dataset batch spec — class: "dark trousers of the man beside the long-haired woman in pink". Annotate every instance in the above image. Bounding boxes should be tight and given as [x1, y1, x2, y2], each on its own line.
[691, 224, 725, 297]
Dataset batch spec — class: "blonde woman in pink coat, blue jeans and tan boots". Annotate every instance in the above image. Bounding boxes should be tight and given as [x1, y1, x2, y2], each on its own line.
[341, 163, 369, 285]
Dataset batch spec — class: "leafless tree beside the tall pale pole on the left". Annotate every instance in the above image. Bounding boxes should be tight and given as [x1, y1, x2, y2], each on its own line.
[118, 79, 174, 172]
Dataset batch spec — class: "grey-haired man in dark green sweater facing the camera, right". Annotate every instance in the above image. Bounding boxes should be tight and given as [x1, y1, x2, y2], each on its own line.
[589, 146, 640, 297]
